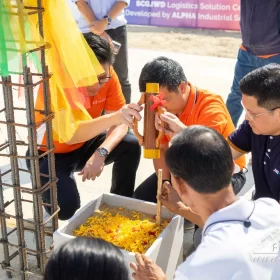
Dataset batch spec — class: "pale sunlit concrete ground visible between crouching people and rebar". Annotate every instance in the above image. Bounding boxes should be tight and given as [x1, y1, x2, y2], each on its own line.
[0, 49, 254, 280]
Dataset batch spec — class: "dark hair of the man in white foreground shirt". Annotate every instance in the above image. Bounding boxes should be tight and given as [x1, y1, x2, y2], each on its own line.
[165, 125, 233, 193]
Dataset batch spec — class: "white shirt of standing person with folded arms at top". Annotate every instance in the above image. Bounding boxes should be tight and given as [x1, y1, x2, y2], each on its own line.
[72, 0, 130, 33]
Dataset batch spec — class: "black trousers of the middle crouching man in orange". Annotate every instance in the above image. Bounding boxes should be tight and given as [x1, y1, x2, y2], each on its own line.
[133, 172, 246, 202]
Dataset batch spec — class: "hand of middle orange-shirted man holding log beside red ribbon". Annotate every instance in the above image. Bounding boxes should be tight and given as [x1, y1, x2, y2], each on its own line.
[155, 112, 186, 137]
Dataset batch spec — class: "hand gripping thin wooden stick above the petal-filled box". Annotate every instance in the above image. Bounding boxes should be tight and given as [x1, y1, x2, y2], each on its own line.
[158, 182, 187, 214]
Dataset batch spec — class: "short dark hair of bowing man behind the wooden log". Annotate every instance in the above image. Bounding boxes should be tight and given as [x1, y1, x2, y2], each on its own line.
[139, 56, 187, 92]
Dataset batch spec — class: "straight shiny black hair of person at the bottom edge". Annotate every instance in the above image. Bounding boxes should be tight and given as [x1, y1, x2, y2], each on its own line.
[44, 237, 129, 280]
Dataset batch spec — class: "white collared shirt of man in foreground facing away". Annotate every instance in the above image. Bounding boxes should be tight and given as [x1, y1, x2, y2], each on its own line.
[175, 198, 280, 280]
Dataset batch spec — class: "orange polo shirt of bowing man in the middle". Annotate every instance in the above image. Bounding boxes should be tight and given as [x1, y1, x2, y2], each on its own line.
[162, 83, 246, 169]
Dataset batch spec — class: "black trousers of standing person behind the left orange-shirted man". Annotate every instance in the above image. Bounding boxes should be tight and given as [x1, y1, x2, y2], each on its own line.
[106, 25, 131, 104]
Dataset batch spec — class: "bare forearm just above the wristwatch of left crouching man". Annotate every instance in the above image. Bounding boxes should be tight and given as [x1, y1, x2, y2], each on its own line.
[101, 124, 128, 153]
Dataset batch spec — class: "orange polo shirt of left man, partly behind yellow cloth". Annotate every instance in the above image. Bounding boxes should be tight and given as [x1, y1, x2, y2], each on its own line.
[35, 68, 125, 153]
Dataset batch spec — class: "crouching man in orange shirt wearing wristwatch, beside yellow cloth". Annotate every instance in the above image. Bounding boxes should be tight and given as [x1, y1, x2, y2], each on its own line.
[27, 35, 141, 220]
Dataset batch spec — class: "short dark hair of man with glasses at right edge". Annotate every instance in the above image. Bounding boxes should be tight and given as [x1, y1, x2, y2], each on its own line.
[240, 63, 280, 110]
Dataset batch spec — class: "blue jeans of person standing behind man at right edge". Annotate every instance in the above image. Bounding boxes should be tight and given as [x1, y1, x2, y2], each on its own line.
[226, 49, 280, 126]
